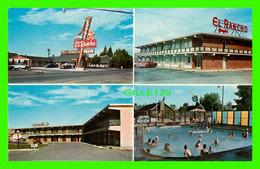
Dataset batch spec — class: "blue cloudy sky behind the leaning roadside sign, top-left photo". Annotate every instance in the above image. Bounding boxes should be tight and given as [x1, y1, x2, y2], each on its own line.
[8, 8, 133, 57]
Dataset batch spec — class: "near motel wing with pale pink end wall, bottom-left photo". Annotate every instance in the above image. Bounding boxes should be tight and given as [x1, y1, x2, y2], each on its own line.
[82, 104, 133, 148]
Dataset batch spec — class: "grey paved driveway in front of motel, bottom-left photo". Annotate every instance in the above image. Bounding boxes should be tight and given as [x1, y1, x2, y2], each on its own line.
[8, 143, 132, 161]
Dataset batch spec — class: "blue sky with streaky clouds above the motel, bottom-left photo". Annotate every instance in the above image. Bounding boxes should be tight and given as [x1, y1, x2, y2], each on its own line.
[8, 85, 133, 128]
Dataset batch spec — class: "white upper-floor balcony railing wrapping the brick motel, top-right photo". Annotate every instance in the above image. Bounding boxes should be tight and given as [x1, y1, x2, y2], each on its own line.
[136, 47, 252, 56]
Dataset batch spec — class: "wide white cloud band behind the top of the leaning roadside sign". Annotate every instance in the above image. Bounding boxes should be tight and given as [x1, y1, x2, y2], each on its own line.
[19, 8, 133, 30]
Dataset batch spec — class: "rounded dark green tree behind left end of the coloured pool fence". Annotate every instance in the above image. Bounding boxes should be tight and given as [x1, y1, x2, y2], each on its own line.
[200, 93, 222, 111]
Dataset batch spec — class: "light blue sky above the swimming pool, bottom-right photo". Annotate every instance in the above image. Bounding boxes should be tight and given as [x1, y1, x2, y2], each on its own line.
[134, 85, 238, 108]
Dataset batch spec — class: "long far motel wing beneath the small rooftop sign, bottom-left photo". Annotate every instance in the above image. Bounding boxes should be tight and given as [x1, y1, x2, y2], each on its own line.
[10, 125, 83, 143]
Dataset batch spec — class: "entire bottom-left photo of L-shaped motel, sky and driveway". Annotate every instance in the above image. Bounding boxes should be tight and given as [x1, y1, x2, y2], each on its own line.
[8, 85, 134, 161]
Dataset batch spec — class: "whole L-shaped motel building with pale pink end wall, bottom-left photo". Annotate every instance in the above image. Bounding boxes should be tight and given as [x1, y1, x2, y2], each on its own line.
[8, 104, 133, 148]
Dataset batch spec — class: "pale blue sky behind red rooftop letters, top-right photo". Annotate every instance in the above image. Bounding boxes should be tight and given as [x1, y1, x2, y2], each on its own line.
[135, 8, 252, 50]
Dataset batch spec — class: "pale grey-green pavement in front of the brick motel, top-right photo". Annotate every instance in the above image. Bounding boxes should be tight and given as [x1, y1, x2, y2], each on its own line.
[135, 67, 252, 84]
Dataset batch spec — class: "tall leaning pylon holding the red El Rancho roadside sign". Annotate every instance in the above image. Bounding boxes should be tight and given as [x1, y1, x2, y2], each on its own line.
[77, 16, 92, 69]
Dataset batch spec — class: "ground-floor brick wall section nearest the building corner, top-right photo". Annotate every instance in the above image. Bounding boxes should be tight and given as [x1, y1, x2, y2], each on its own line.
[202, 55, 223, 70]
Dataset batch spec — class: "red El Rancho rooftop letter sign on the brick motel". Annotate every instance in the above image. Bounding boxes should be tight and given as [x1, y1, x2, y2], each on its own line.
[212, 17, 248, 33]
